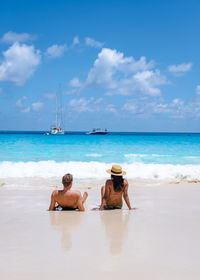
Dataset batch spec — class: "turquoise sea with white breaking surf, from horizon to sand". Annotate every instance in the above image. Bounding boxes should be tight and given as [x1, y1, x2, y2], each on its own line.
[0, 131, 200, 179]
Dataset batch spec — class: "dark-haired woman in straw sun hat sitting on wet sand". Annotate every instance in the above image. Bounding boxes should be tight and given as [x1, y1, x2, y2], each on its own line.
[99, 164, 134, 210]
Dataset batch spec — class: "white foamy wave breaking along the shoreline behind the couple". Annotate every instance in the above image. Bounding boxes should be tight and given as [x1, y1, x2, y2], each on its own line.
[0, 161, 200, 180]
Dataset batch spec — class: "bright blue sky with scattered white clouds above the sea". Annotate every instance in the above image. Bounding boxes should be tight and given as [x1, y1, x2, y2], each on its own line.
[0, 0, 200, 132]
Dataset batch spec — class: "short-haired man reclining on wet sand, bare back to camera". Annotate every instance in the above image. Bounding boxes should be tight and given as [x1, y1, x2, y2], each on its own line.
[49, 173, 88, 211]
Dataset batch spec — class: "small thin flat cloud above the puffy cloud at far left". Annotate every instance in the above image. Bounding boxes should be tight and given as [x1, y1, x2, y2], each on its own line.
[1, 31, 35, 44]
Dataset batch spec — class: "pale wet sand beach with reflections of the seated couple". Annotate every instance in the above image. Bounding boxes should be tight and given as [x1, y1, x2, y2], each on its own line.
[0, 179, 200, 280]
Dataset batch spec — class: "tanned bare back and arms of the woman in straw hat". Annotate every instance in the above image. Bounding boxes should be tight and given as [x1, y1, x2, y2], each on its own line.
[99, 179, 135, 211]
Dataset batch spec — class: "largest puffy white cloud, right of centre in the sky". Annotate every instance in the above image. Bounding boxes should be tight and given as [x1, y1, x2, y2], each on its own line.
[70, 48, 167, 96]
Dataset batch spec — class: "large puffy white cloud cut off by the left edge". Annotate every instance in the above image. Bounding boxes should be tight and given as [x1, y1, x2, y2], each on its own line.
[0, 43, 41, 86]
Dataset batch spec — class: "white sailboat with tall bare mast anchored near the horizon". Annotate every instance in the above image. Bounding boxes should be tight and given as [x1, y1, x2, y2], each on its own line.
[51, 87, 65, 135]
